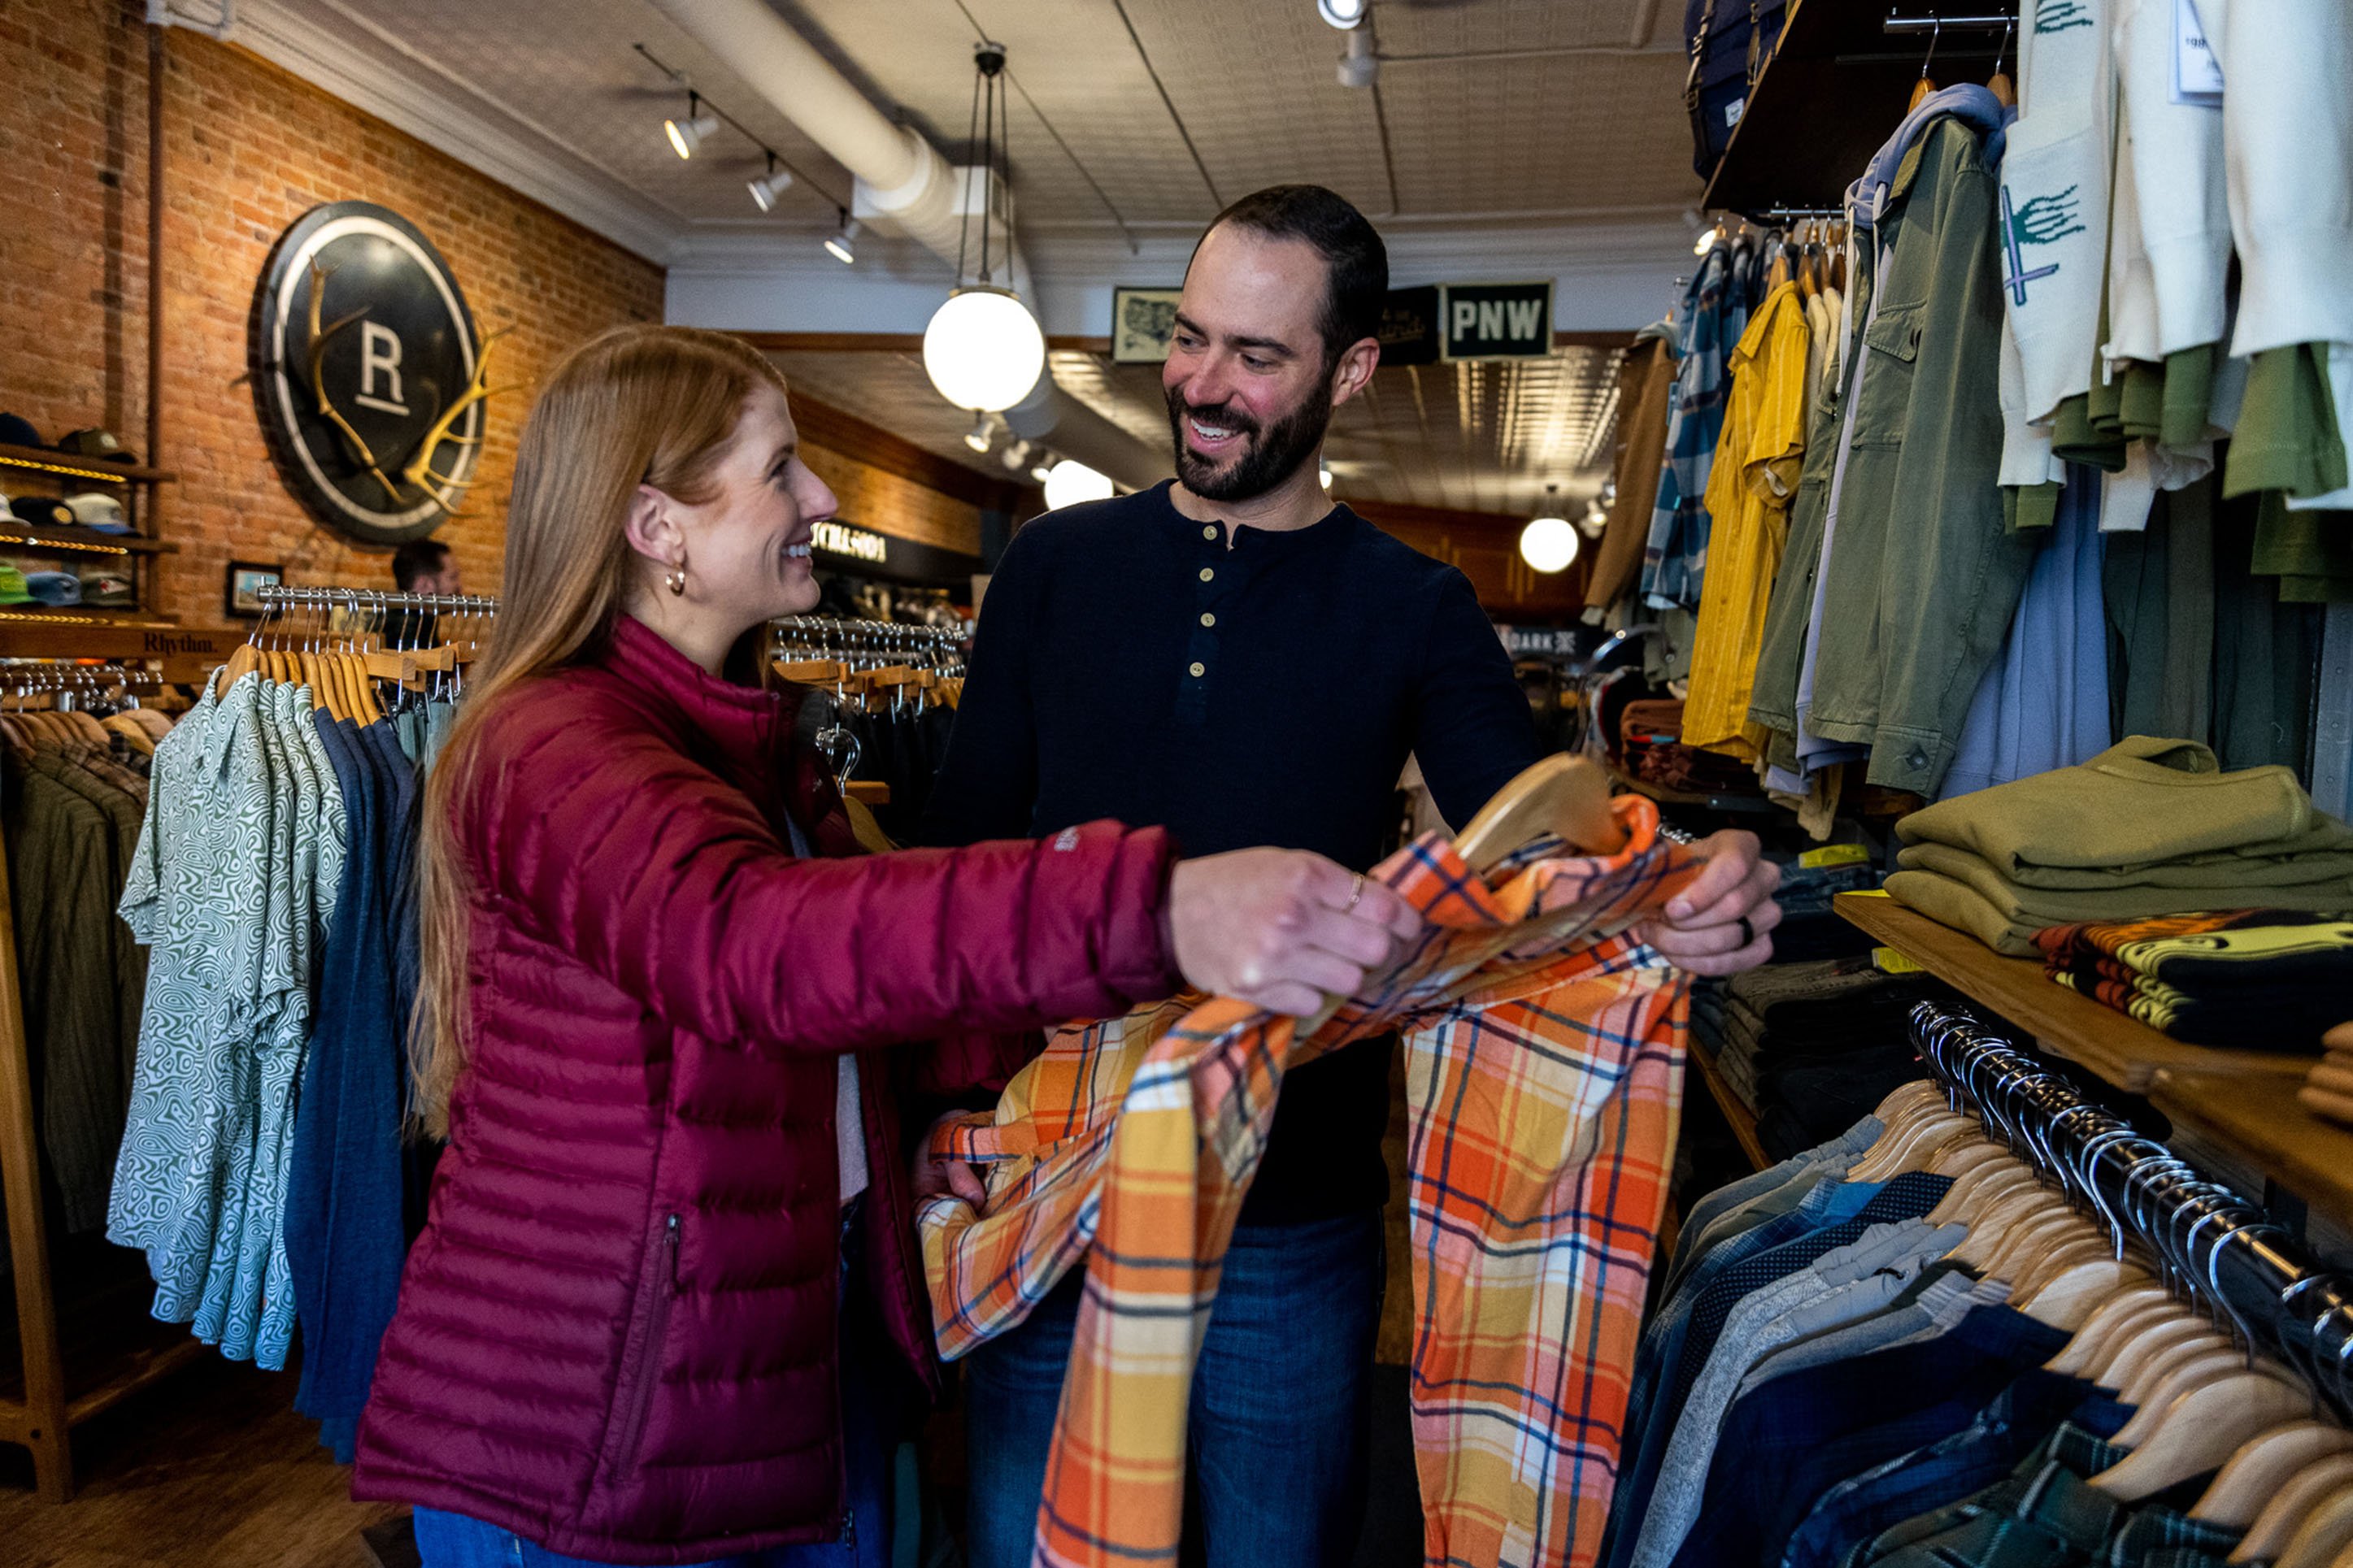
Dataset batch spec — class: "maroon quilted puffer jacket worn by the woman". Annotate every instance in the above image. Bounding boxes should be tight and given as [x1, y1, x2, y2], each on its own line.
[353, 619, 1176, 1563]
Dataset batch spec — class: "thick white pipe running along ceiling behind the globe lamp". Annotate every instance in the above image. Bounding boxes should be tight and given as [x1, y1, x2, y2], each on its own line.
[655, 0, 1172, 489]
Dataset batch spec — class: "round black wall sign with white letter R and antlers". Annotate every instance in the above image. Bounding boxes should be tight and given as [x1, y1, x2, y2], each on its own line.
[254, 202, 485, 545]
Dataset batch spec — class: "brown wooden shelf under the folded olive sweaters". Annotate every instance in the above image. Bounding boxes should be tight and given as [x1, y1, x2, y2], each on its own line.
[1833, 893, 2353, 1236]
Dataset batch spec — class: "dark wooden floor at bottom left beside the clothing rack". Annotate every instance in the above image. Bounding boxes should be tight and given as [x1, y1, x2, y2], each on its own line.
[0, 1357, 402, 1568]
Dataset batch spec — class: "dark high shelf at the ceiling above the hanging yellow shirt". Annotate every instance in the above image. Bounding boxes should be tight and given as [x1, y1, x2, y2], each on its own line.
[1701, 0, 2016, 219]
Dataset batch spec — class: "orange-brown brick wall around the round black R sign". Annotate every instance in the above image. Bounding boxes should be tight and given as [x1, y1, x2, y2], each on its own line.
[0, 0, 663, 623]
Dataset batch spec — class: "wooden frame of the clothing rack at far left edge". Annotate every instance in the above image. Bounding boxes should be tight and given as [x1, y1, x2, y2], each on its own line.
[0, 658, 205, 1502]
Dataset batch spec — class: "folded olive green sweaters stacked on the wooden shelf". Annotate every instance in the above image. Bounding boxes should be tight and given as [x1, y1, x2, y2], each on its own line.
[1887, 736, 2353, 957]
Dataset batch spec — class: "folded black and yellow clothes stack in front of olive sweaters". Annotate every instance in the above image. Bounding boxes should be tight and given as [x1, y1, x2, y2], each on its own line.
[2035, 910, 2353, 1051]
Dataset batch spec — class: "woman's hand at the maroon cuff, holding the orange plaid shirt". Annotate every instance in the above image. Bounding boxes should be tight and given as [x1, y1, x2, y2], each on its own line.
[1167, 849, 1421, 1018]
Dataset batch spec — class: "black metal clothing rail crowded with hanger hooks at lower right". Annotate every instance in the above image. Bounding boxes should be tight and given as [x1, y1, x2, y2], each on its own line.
[1911, 1001, 2353, 1415]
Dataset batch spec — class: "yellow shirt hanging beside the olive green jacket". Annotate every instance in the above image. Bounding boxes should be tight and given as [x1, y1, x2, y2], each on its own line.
[1682, 282, 1812, 762]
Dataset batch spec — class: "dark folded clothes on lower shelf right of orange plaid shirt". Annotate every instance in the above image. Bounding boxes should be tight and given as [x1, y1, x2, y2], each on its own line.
[1692, 954, 1955, 1159]
